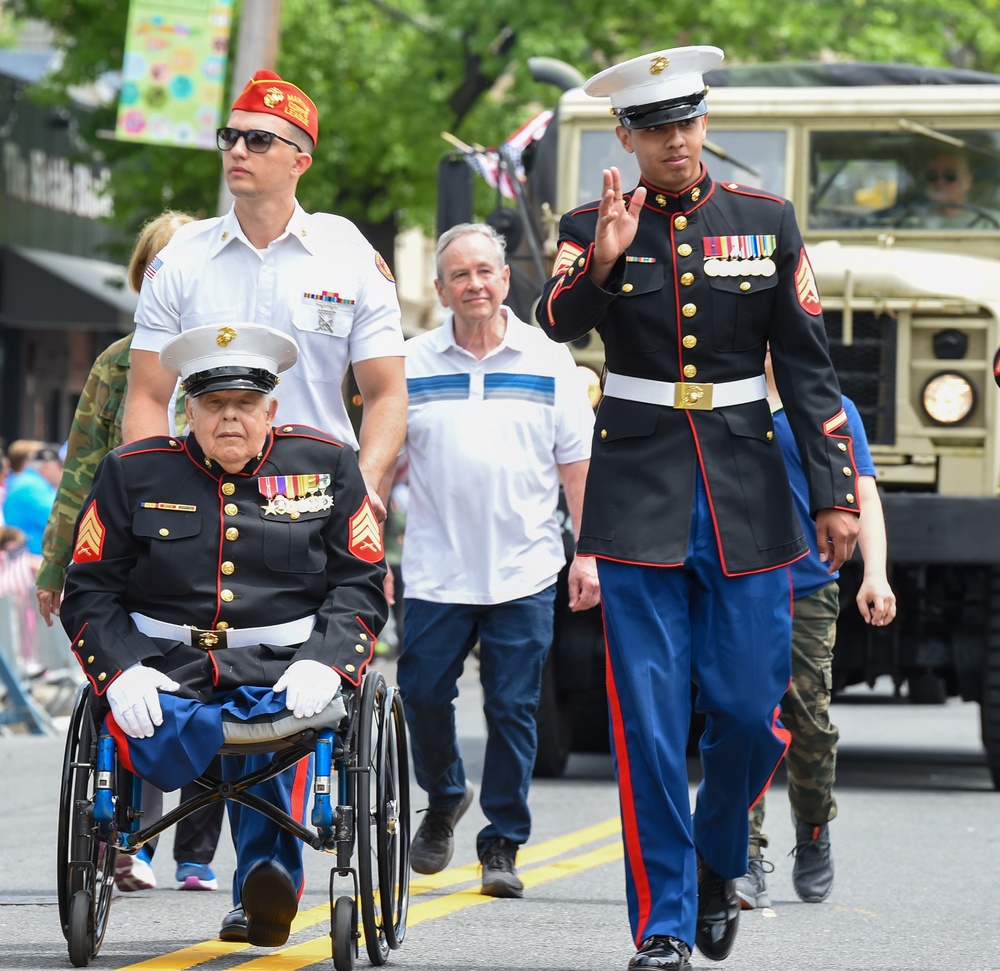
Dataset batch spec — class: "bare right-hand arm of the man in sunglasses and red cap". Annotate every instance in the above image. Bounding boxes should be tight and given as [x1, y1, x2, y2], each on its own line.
[353, 357, 407, 522]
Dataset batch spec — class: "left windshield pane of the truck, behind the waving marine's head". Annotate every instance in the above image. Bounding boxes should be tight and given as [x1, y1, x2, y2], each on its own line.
[575, 125, 786, 206]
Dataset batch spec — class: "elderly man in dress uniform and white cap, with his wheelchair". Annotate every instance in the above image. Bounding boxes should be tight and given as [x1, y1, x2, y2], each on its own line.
[53, 323, 409, 969]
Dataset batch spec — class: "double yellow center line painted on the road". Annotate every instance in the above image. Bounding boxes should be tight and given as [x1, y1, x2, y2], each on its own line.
[109, 817, 623, 971]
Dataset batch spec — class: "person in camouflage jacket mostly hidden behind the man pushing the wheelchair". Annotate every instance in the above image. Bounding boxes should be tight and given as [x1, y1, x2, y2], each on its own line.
[35, 210, 225, 891]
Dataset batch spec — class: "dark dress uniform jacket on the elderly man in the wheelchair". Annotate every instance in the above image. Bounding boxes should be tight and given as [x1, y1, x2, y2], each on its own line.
[61, 425, 388, 701]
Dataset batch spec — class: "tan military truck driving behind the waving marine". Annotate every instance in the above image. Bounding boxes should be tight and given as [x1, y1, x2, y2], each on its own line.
[445, 61, 1000, 788]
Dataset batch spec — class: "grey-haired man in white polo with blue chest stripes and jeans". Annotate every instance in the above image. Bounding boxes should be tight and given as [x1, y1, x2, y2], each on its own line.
[397, 223, 600, 897]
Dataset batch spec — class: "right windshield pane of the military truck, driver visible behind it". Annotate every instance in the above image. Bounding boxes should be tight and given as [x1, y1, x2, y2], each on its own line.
[809, 128, 1000, 232]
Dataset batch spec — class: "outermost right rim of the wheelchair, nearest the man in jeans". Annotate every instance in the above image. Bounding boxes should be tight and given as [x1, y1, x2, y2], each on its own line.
[375, 688, 410, 949]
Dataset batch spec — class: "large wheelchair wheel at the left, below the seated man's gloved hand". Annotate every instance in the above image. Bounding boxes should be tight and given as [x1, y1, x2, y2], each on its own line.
[56, 684, 118, 967]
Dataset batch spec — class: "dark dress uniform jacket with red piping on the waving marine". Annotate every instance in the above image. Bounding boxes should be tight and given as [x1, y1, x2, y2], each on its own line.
[537, 167, 859, 575]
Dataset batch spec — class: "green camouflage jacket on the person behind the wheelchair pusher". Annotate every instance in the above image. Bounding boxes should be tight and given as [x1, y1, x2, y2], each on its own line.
[35, 334, 186, 591]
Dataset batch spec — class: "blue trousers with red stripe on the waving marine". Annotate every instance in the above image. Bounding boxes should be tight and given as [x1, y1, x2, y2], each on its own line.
[598, 476, 791, 946]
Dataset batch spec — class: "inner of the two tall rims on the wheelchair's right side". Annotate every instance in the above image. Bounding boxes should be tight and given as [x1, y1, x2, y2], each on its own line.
[355, 670, 389, 966]
